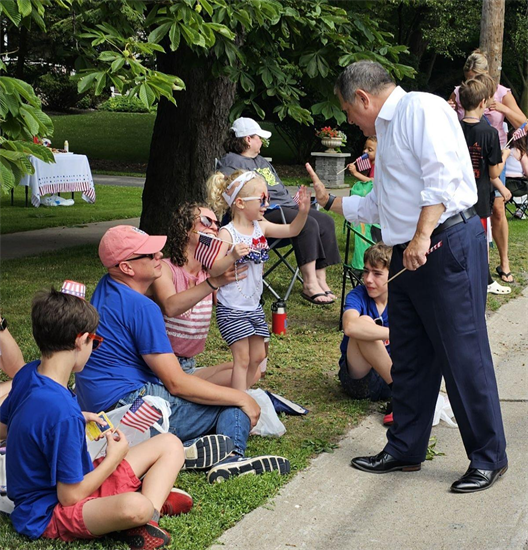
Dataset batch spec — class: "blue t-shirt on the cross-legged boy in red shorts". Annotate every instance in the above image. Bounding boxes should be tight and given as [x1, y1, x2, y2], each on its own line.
[0, 361, 93, 539]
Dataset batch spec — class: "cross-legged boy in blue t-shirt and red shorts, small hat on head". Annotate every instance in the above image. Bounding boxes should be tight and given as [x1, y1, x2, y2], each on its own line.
[0, 281, 192, 549]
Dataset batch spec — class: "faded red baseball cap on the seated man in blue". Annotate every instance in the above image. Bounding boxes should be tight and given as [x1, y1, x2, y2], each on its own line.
[99, 225, 167, 267]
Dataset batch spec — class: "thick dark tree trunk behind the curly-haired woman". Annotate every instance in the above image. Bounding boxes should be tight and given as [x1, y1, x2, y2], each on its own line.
[141, 46, 236, 235]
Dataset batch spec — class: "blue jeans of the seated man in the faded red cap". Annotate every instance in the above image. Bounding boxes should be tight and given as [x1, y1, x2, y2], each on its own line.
[119, 382, 251, 456]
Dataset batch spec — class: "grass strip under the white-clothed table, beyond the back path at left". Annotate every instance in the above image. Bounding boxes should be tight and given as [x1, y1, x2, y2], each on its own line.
[0, 185, 143, 234]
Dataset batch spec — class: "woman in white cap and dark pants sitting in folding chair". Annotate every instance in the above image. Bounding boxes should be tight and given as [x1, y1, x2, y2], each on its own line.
[217, 118, 341, 305]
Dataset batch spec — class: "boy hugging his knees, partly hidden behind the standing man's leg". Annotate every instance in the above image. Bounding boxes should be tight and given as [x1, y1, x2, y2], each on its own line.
[339, 243, 392, 425]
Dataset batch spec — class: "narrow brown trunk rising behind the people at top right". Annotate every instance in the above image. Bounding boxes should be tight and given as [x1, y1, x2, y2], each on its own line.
[480, 0, 505, 84]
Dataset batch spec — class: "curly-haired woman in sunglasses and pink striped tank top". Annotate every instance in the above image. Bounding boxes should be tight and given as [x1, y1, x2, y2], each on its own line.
[149, 202, 259, 386]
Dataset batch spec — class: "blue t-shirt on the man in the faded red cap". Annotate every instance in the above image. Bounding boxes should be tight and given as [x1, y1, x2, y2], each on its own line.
[75, 275, 173, 412]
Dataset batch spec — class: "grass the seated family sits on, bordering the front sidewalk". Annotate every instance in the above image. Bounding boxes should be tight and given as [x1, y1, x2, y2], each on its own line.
[0, 218, 528, 550]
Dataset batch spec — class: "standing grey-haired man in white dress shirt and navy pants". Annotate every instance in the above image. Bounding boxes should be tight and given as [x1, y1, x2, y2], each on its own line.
[307, 61, 508, 493]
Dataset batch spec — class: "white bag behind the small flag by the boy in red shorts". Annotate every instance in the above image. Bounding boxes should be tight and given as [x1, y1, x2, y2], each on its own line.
[86, 395, 171, 460]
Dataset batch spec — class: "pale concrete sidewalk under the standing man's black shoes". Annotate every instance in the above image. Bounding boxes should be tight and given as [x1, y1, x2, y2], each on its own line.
[211, 290, 528, 550]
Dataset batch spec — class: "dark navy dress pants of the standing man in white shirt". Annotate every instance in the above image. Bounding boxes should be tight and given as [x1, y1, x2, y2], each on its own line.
[385, 216, 507, 470]
